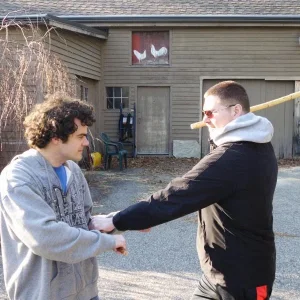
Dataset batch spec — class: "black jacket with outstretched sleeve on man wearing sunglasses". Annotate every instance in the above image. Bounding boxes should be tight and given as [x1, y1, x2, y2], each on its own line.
[113, 142, 278, 289]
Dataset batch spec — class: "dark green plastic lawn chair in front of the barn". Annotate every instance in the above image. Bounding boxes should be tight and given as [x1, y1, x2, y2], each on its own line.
[100, 132, 127, 171]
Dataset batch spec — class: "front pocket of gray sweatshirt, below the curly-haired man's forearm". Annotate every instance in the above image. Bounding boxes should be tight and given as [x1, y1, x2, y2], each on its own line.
[50, 262, 77, 300]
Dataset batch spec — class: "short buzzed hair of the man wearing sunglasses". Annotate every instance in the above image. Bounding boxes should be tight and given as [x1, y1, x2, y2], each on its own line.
[204, 80, 250, 112]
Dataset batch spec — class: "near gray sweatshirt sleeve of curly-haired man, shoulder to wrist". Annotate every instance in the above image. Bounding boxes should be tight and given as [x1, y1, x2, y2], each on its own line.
[1, 186, 115, 263]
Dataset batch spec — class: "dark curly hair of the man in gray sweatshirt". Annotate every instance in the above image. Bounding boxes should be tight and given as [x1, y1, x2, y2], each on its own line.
[23, 94, 96, 148]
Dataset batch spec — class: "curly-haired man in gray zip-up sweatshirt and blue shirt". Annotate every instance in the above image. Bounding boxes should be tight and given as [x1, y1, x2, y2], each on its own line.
[0, 95, 126, 300]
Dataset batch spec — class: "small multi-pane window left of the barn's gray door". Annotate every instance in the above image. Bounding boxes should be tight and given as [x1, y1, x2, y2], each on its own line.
[106, 87, 129, 109]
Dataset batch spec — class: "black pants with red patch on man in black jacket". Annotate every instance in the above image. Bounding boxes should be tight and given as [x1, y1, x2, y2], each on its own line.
[191, 275, 272, 300]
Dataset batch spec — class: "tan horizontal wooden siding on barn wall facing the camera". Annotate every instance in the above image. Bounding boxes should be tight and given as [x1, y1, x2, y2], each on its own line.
[103, 27, 300, 157]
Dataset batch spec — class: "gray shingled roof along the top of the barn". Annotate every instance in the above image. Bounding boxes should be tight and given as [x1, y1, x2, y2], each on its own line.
[0, 0, 300, 16]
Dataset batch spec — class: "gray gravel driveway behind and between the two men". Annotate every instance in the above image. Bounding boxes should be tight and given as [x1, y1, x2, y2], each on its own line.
[0, 167, 300, 300]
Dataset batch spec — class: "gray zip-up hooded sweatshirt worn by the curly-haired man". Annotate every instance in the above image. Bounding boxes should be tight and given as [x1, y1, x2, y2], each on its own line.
[0, 149, 115, 300]
